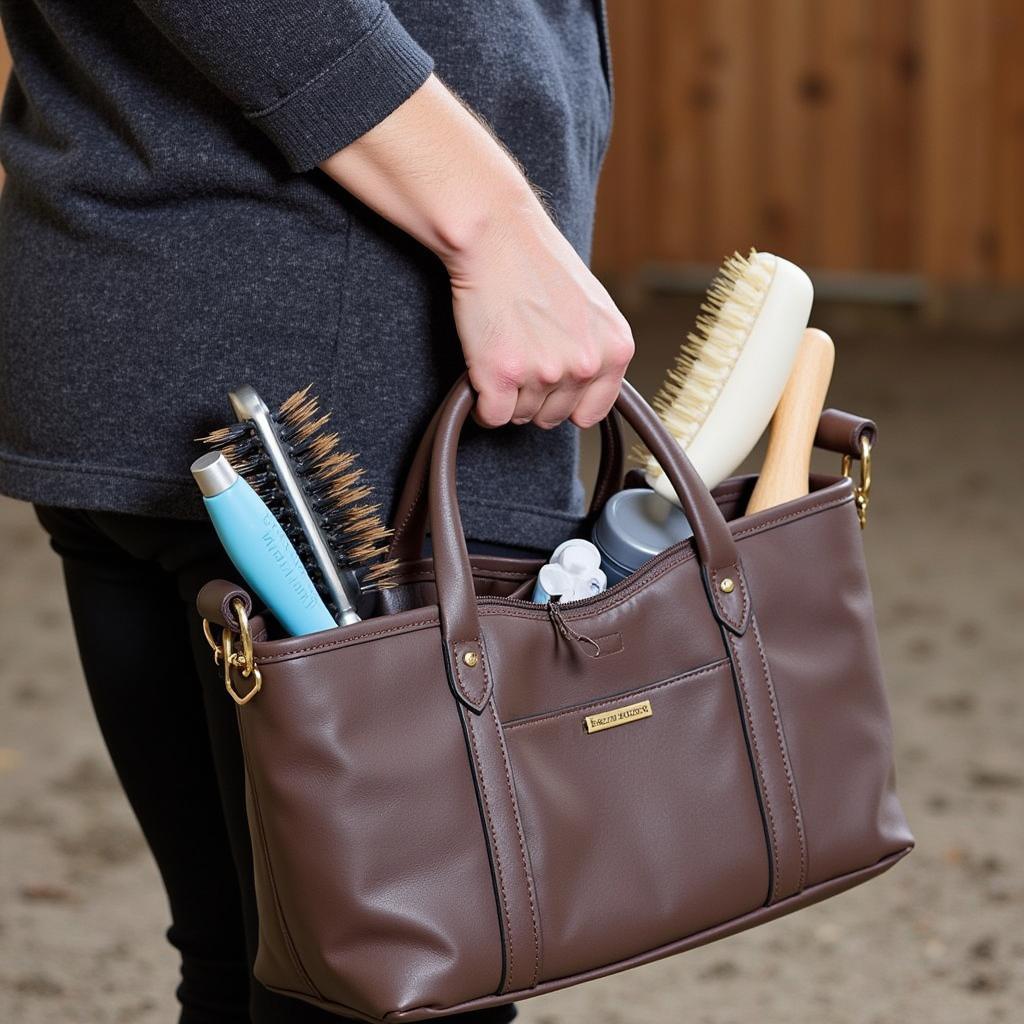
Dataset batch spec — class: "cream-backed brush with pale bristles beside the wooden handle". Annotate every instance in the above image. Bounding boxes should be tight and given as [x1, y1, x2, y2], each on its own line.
[631, 249, 814, 505]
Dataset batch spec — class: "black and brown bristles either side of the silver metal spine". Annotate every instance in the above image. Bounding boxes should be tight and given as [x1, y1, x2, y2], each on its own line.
[197, 384, 398, 605]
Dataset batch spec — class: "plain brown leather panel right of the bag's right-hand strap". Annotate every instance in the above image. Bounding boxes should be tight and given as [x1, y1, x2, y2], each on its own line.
[740, 496, 913, 886]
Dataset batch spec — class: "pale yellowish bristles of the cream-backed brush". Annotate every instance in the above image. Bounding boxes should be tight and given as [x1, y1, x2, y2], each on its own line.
[630, 249, 772, 477]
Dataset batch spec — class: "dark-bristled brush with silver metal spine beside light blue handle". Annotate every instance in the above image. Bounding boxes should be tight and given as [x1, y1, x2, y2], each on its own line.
[198, 385, 397, 626]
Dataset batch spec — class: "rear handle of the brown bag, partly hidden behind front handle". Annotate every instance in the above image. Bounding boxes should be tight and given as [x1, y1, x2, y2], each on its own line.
[385, 402, 625, 561]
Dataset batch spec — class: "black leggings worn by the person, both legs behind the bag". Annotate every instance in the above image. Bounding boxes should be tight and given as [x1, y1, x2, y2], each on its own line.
[35, 505, 545, 1024]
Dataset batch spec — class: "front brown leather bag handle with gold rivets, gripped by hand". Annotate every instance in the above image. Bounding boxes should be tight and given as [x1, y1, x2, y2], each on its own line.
[430, 373, 750, 712]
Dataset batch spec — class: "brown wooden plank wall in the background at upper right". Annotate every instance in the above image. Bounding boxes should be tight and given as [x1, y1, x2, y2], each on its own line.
[594, 0, 1024, 285]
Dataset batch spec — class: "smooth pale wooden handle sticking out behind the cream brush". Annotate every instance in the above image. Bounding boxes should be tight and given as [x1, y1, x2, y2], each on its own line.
[746, 328, 836, 515]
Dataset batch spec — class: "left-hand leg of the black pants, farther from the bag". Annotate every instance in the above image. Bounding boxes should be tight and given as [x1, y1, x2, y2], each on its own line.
[37, 507, 250, 1024]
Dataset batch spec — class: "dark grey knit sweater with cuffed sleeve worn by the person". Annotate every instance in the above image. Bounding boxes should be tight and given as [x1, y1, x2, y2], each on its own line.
[0, 0, 611, 547]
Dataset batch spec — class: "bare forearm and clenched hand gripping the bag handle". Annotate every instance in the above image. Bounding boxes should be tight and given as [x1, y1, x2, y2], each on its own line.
[319, 75, 634, 428]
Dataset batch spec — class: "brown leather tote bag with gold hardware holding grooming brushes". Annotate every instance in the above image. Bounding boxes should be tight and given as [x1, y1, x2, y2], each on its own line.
[199, 374, 913, 1022]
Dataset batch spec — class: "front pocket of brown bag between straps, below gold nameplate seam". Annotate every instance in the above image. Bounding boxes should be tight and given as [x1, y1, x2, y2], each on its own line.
[504, 662, 768, 981]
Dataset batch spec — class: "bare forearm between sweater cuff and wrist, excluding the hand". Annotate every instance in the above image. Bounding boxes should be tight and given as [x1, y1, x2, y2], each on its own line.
[319, 75, 544, 264]
